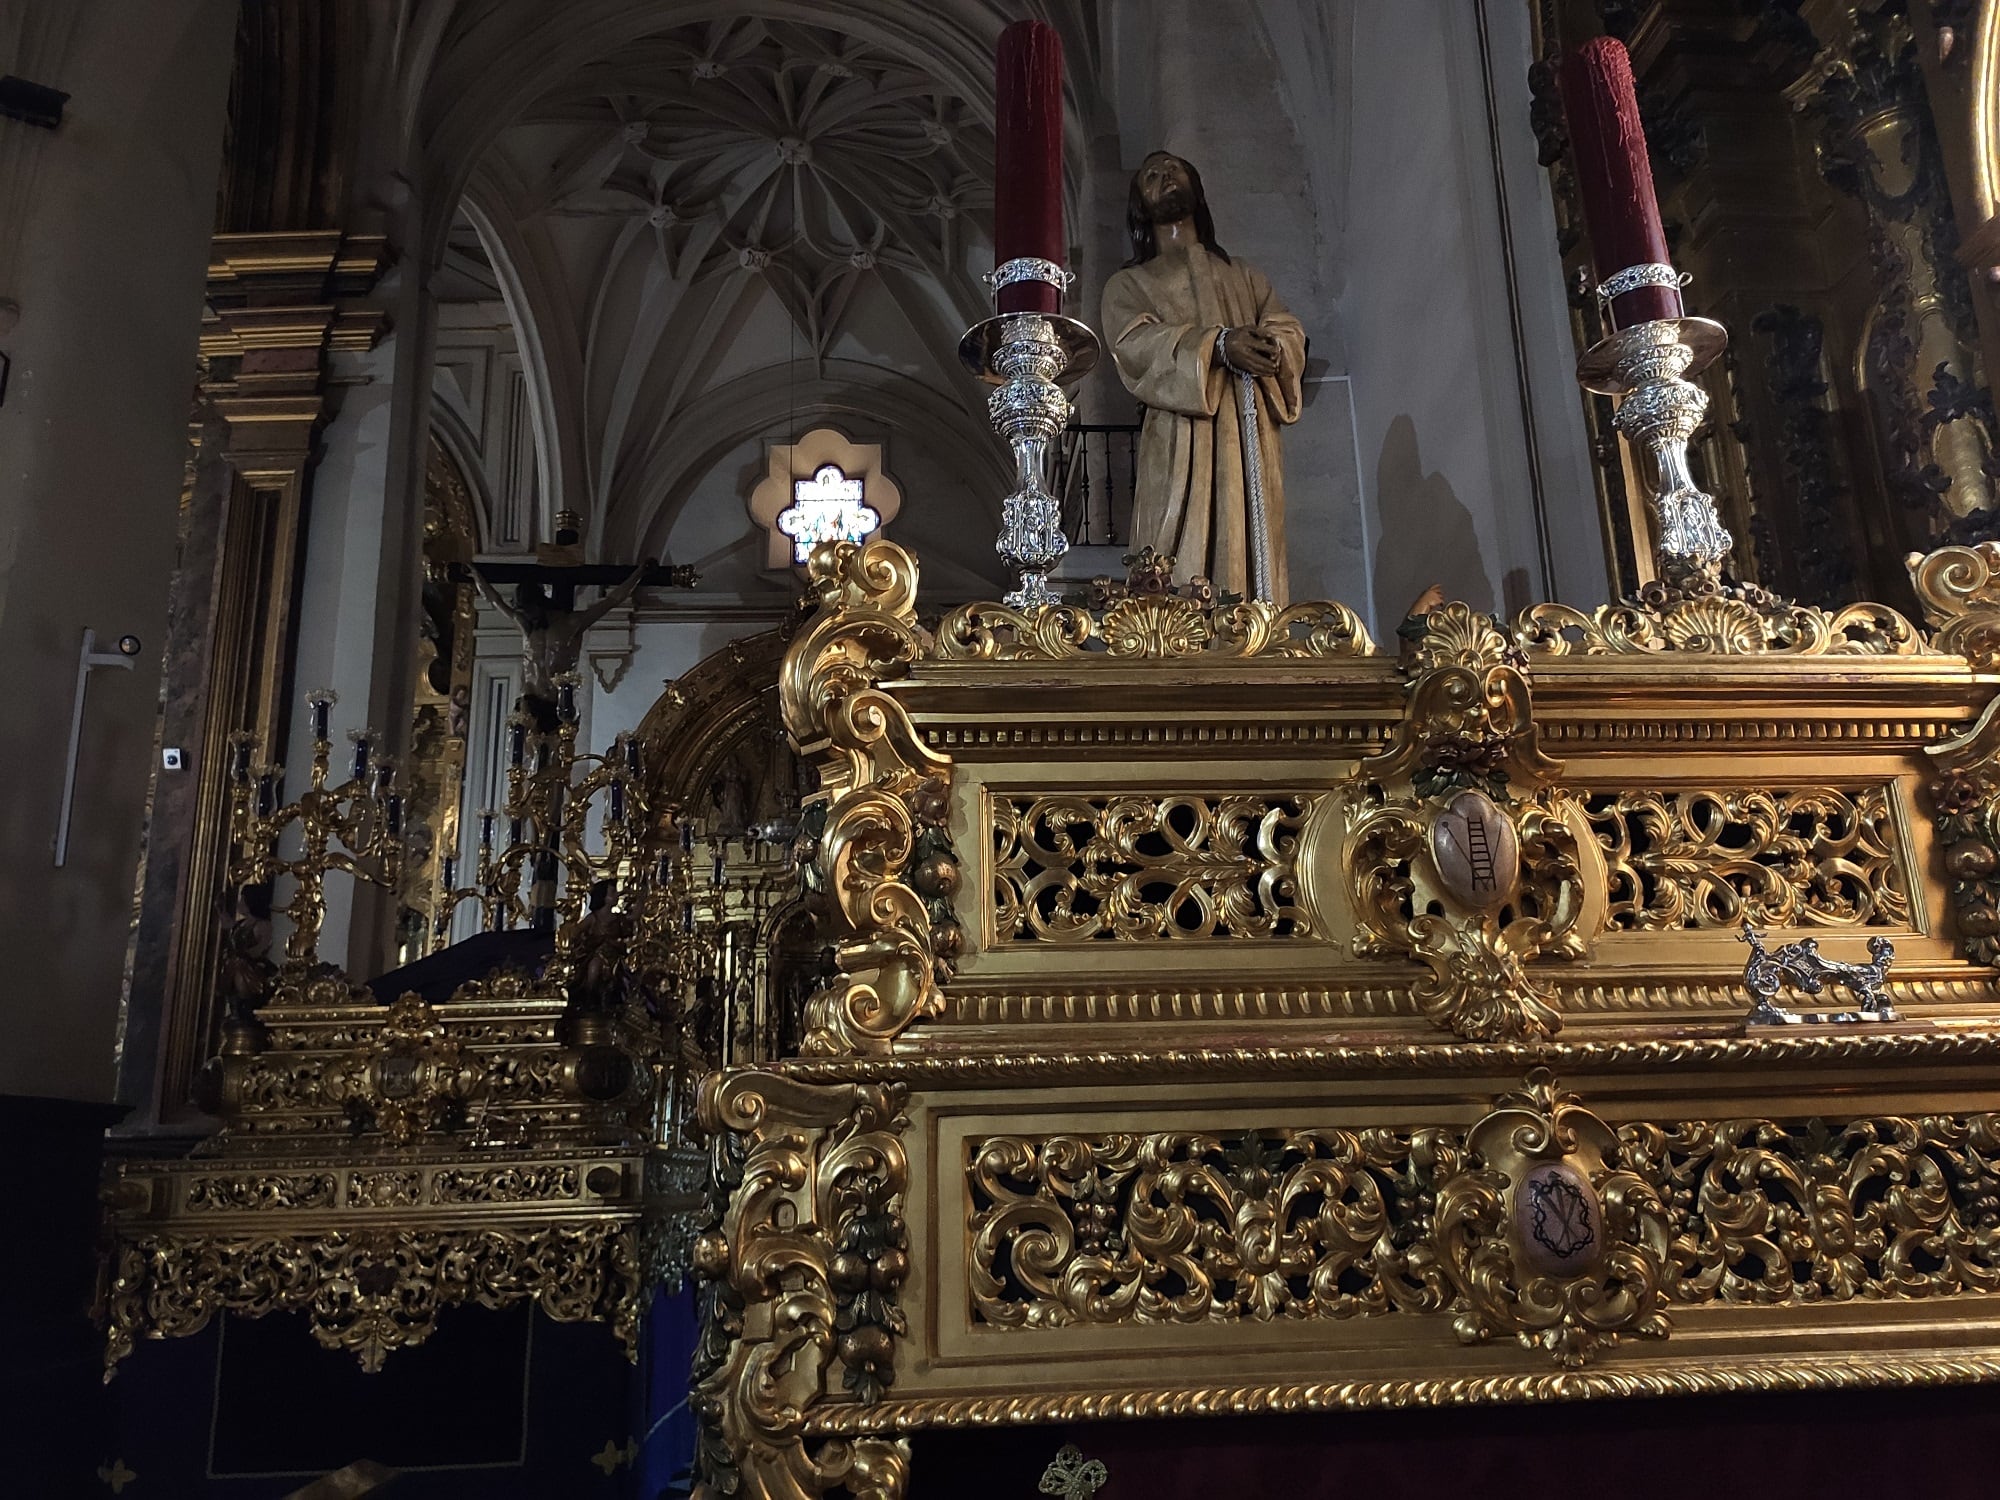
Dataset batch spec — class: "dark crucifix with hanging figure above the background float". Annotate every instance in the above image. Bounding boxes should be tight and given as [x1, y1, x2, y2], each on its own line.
[460, 528, 700, 734]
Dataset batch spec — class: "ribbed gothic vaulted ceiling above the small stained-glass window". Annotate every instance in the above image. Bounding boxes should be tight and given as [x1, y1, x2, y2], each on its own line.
[416, 0, 1082, 572]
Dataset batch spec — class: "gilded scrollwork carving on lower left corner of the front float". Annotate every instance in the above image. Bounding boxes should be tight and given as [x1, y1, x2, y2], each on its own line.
[694, 1074, 910, 1500]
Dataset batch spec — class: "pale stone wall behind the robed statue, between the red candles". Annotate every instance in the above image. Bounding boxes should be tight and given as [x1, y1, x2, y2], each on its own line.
[1084, 0, 1606, 634]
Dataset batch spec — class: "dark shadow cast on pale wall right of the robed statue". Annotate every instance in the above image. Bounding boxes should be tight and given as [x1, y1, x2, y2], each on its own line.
[1374, 416, 1494, 634]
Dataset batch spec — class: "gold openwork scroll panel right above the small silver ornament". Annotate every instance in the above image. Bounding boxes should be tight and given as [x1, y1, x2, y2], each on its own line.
[1584, 786, 1910, 932]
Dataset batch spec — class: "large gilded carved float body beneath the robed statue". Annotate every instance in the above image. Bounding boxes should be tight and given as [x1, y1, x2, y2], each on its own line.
[696, 544, 2000, 1496]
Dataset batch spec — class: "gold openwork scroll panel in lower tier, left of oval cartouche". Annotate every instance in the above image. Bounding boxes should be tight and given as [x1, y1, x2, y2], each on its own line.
[966, 1130, 1454, 1328]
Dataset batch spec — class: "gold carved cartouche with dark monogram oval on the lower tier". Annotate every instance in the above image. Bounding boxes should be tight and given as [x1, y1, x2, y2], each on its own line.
[1434, 1070, 1670, 1368]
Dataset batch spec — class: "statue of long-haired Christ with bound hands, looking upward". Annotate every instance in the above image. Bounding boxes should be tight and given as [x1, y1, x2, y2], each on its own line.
[1102, 152, 1306, 604]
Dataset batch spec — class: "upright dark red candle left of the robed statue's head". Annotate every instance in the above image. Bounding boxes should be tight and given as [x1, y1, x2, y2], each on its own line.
[994, 20, 1066, 312]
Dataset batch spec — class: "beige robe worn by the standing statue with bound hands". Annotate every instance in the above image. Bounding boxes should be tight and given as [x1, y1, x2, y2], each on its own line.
[1104, 244, 1306, 604]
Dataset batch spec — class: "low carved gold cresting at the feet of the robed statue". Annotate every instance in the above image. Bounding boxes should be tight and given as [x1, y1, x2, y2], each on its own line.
[934, 594, 1376, 662]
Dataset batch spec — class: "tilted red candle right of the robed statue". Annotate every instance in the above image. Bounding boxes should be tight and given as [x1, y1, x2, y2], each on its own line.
[1562, 36, 1682, 328]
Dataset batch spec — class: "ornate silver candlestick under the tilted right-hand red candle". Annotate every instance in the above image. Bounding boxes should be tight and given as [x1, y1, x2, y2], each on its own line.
[1576, 318, 1730, 578]
